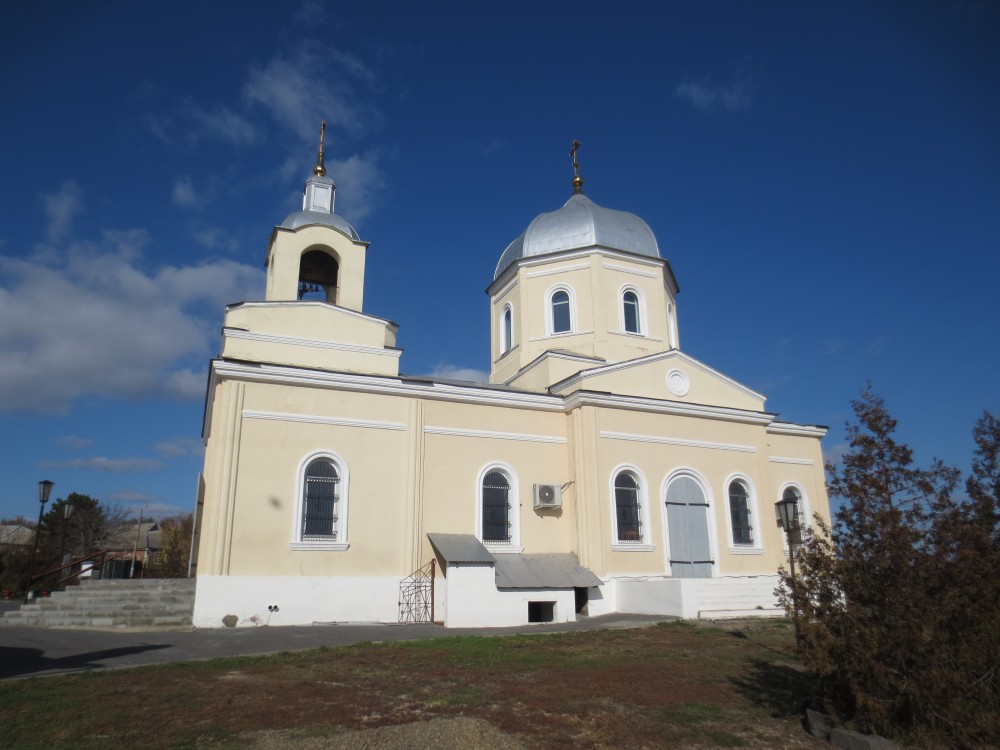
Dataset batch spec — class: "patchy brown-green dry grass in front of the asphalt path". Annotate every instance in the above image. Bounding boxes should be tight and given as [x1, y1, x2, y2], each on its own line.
[0, 621, 825, 750]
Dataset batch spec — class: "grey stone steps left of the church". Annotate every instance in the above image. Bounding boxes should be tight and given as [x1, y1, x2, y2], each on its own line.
[0, 578, 195, 630]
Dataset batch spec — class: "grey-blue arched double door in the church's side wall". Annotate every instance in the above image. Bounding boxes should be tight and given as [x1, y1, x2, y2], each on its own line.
[666, 477, 714, 578]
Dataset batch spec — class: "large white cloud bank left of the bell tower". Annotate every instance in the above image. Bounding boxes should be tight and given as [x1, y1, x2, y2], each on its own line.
[0, 191, 264, 413]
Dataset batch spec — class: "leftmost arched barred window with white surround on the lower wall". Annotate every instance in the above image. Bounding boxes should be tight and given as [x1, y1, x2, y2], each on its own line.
[291, 452, 349, 550]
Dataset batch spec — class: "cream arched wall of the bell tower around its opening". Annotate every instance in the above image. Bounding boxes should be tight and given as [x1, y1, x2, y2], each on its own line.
[266, 225, 367, 310]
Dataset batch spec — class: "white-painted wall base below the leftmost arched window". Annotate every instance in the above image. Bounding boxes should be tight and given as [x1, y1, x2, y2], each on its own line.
[193, 576, 400, 628]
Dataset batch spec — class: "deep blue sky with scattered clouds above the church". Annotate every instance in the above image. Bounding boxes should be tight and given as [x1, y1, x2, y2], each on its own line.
[0, 0, 1000, 517]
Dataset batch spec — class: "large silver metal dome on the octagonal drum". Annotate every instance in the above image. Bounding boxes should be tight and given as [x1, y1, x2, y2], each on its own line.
[493, 193, 660, 279]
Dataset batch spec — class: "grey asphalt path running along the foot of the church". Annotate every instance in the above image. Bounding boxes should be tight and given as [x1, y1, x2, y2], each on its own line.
[0, 614, 674, 680]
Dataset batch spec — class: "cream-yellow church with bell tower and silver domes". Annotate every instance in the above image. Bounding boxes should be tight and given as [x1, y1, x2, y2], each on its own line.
[192, 134, 829, 627]
